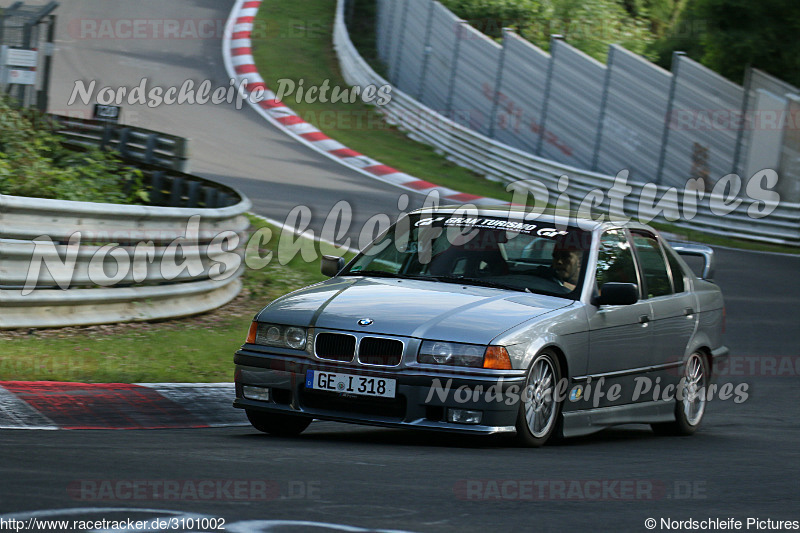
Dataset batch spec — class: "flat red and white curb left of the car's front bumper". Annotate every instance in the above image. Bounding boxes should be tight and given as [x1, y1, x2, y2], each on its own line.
[0, 381, 249, 429]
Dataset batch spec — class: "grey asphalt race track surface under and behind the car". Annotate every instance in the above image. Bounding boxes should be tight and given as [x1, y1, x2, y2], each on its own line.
[0, 0, 800, 531]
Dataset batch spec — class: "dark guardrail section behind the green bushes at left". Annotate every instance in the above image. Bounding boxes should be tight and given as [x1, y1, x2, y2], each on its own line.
[48, 115, 189, 172]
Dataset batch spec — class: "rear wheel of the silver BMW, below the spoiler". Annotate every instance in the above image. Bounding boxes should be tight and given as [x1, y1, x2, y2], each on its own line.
[650, 352, 709, 436]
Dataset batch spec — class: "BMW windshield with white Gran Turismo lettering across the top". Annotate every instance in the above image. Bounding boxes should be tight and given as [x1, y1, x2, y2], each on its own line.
[341, 215, 591, 299]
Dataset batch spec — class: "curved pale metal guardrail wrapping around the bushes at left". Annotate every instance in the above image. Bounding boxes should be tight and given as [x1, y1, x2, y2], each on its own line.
[0, 119, 252, 329]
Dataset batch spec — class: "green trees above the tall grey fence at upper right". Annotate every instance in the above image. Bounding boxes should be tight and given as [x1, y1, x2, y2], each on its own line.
[441, 0, 800, 85]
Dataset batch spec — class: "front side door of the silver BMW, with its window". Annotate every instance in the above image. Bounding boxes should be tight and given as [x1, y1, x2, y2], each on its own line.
[587, 228, 653, 407]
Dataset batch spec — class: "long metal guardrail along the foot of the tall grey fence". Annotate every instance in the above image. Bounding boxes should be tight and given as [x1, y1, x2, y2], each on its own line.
[333, 0, 800, 246]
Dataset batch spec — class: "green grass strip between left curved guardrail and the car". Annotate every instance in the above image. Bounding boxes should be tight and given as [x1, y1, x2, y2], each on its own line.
[0, 219, 342, 383]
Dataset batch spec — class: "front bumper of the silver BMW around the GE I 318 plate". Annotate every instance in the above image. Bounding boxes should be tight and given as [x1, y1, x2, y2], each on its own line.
[233, 349, 525, 435]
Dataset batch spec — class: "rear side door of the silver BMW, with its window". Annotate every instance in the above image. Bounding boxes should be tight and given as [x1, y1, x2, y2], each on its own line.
[631, 229, 697, 386]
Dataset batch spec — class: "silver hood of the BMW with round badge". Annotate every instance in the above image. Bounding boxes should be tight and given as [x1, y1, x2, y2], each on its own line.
[258, 277, 572, 344]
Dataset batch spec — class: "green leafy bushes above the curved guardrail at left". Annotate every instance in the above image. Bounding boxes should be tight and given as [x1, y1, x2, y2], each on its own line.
[0, 99, 148, 204]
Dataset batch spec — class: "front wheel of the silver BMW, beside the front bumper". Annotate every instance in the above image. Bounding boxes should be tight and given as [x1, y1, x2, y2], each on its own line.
[517, 350, 563, 448]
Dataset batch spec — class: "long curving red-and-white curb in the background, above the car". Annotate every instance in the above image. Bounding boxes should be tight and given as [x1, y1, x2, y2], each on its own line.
[222, 0, 508, 205]
